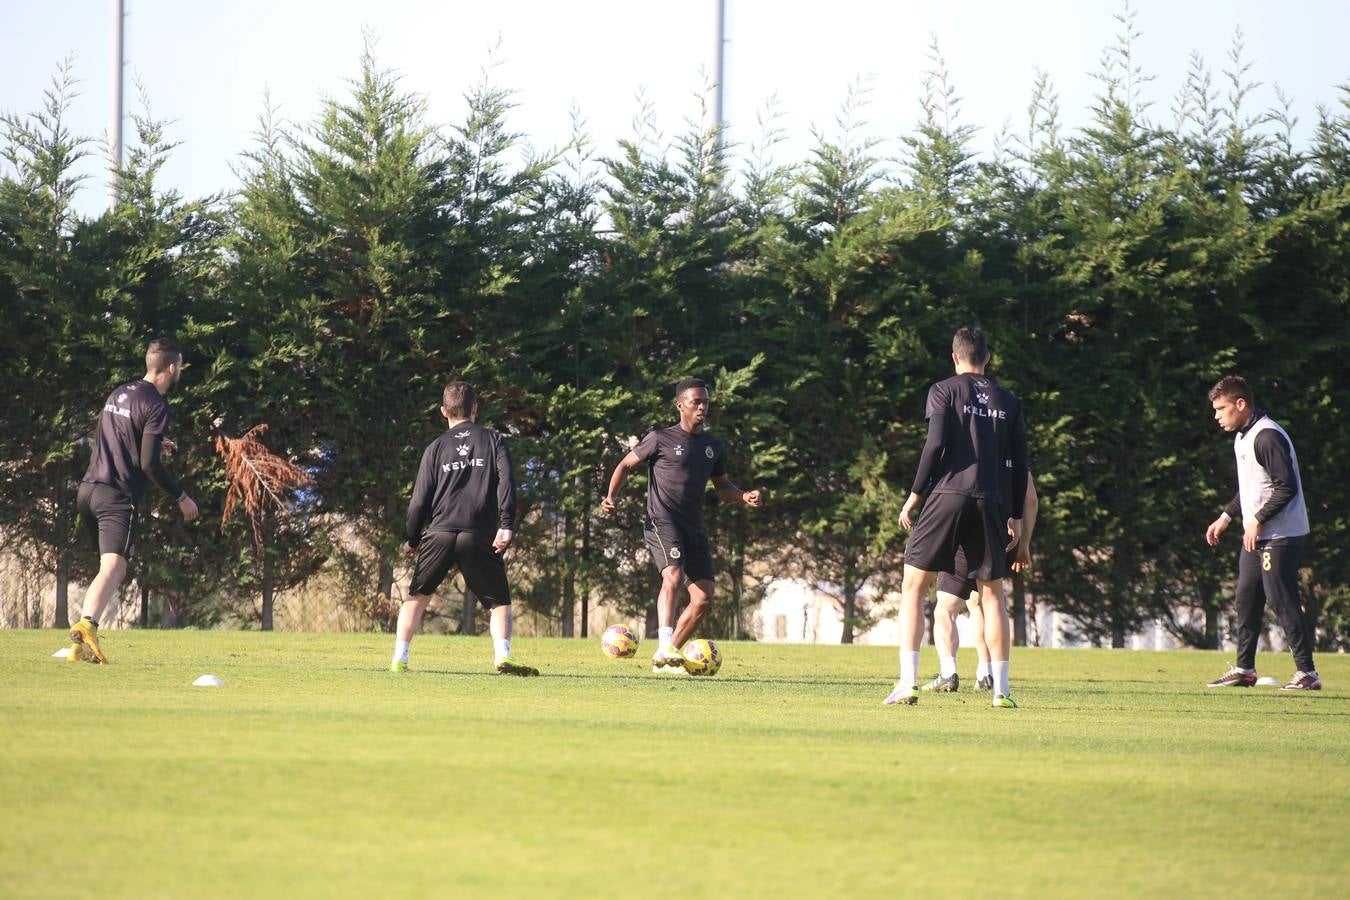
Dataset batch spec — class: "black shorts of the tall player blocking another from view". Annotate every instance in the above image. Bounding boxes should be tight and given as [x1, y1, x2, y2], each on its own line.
[905, 494, 1008, 582]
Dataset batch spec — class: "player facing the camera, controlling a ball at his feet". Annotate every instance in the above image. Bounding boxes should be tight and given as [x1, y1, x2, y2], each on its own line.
[601, 378, 761, 672]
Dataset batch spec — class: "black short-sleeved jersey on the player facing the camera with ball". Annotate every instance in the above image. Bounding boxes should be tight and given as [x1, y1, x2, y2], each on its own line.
[633, 425, 726, 532]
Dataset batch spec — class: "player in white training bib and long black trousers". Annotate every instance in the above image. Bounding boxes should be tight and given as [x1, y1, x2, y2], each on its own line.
[1204, 375, 1322, 691]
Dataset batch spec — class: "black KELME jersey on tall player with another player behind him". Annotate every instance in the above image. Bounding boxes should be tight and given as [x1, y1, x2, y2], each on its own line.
[914, 372, 1026, 518]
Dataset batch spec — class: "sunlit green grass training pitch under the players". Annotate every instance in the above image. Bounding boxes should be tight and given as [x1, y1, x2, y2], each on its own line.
[0, 631, 1350, 897]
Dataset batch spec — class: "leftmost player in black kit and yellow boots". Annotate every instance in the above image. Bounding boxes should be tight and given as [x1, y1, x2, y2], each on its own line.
[68, 337, 197, 663]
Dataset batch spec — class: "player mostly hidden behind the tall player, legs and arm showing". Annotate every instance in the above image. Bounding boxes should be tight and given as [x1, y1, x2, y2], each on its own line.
[922, 472, 1040, 692]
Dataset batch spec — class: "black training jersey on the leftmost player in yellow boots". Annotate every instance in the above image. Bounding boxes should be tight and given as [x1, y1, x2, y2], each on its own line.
[84, 378, 177, 503]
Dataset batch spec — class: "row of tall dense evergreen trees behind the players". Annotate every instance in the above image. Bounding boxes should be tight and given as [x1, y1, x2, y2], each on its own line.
[0, 29, 1350, 648]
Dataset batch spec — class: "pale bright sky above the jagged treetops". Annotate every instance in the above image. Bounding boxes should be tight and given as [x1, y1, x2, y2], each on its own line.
[0, 0, 1350, 212]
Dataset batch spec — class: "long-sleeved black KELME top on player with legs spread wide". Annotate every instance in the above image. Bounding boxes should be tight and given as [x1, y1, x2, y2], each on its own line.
[408, 422, 516, 546]
